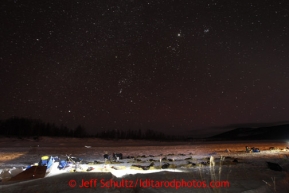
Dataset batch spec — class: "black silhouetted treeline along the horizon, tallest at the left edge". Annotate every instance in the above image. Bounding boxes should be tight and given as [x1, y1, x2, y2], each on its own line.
[0, 117, 177, 140]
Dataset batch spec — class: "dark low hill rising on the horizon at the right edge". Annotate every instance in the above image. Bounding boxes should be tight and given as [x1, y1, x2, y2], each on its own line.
[208, 124, 289, 140]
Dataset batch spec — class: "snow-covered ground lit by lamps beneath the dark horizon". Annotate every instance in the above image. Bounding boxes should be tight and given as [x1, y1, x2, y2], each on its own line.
[0, 137, 289, 193]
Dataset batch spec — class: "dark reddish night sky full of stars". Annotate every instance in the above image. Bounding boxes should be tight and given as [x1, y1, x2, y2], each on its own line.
[0, 0, 289, 137]
